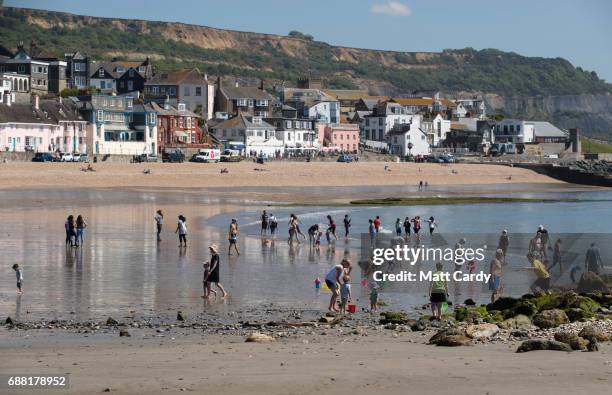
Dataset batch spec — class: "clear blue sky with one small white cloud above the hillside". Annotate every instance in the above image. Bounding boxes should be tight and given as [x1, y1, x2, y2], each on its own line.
[0, 0, 612, 82]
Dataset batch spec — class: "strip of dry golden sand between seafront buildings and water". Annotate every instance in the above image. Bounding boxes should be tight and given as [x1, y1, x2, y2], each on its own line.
[0, 161, 562, 188]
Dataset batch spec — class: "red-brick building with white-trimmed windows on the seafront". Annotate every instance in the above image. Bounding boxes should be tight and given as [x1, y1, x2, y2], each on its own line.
[150, 102, 204, 153]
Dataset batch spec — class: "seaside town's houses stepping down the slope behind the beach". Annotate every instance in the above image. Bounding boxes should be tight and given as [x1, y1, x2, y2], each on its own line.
[0, 43, 568, 156]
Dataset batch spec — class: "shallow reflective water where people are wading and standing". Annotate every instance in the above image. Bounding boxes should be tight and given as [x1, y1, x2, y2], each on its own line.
[0, 189, 612, 320]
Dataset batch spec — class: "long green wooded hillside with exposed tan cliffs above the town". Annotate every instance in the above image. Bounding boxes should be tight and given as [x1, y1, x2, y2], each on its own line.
[0, 7, 612, 140]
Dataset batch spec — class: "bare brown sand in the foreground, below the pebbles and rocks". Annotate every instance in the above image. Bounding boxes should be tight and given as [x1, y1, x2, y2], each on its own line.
[0, 329, 612, 395]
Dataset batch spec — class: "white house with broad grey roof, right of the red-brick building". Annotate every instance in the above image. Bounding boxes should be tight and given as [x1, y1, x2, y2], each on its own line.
[212, 113, 284, 156]
